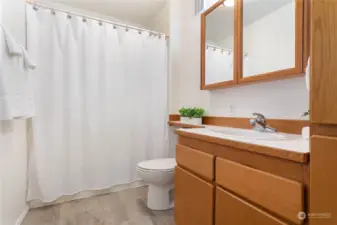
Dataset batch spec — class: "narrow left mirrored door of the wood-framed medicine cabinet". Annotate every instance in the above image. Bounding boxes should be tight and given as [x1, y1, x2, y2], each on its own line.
[202, 0, 235, 89]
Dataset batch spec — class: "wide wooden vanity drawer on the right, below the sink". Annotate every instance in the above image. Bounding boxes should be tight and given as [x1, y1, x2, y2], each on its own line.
[216, 158, 304, 224]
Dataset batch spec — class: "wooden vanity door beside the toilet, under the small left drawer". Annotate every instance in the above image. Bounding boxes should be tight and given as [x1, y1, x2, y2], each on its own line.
[174, 166, 214, 225]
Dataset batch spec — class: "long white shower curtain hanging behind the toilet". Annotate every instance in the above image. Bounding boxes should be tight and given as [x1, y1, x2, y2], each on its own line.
[27, 5, 168, 202]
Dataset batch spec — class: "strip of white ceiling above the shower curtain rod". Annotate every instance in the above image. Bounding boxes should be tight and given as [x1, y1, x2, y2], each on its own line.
[36, 0, 168, 25]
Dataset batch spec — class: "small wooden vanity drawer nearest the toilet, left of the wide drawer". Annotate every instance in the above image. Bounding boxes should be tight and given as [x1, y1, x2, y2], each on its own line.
[176, 145, 214, 180]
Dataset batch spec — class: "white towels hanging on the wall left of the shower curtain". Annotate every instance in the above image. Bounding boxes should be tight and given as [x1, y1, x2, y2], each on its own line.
[0, 24, 35, 121]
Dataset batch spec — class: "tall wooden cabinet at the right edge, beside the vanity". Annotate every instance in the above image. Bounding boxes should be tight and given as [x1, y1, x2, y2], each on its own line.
[309, 0, 337, 225]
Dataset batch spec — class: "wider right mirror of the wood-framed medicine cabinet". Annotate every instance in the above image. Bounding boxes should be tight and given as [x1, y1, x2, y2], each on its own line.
[241, 0, 300, 80]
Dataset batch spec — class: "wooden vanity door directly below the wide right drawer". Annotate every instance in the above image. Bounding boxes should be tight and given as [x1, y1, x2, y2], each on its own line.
[215, 188, 288, 225]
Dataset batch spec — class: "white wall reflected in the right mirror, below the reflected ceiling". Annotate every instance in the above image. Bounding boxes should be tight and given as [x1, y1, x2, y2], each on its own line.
[243, 1, 295, 77]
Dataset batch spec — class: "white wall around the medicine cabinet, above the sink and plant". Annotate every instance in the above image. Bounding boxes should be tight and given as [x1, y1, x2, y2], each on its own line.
[170, 0, 309, 119]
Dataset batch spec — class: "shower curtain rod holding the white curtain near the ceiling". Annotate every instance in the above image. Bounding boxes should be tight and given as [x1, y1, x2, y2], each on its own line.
[26, 1, 169, 38]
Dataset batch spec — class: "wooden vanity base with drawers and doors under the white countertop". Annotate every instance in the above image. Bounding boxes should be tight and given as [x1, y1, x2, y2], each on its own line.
[175, 133, 309, 225]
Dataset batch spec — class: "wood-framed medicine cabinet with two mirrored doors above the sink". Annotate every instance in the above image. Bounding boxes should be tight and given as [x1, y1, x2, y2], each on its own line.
[201, 0, 310, 90]
